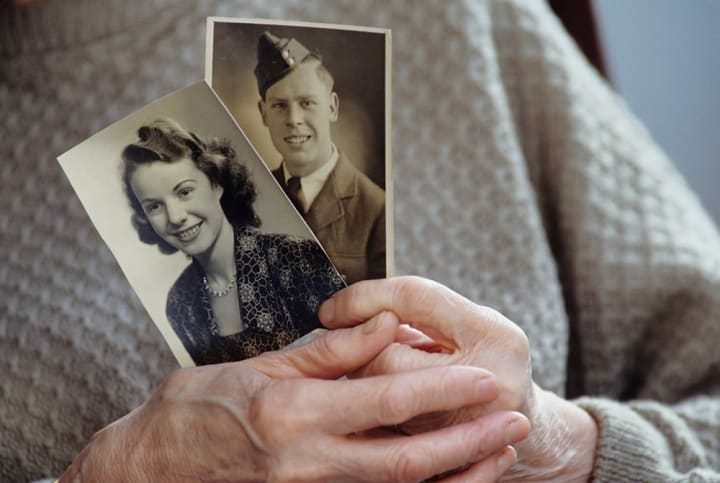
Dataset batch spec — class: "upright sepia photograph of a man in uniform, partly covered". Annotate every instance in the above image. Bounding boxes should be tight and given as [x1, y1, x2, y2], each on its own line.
[205, 17, 393, 283]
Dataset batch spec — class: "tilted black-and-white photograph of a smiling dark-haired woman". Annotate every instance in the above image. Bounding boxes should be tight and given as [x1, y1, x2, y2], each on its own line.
[58, 82, 344, 366]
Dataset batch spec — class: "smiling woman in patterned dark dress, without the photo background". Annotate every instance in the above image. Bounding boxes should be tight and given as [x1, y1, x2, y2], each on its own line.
[122, 119, 343, 365]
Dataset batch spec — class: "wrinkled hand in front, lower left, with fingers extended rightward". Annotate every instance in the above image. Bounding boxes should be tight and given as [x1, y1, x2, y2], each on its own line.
[61, 312, 529, 482]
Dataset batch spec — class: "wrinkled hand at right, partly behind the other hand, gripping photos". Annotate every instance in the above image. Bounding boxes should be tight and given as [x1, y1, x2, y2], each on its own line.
[319, 277, 597, 481]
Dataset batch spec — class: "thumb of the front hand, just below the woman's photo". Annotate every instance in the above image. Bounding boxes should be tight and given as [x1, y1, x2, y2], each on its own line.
[243, 312, 398, 379]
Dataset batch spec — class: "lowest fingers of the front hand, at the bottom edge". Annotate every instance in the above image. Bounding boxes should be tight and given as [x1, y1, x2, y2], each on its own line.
[337, 412, 530, 482]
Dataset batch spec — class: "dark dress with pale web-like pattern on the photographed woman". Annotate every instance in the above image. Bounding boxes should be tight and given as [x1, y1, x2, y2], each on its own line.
[166, 228, 345, 365]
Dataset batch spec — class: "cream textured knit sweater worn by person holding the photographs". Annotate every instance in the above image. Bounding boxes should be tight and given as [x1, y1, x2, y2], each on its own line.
[0, 0, 720, 481]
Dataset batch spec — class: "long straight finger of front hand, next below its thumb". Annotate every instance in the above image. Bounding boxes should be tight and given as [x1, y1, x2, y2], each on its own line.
[298, 366, 498, 435]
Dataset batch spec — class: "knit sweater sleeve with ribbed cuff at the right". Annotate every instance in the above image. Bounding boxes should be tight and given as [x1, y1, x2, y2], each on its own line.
[493, 1, 720, 481]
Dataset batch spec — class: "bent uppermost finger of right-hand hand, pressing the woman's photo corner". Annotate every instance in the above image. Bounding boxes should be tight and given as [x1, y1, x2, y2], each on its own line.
[318, 277, 489, 344]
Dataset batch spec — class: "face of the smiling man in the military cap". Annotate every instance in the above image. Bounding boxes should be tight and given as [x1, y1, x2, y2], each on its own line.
[259, 61, 338, 176]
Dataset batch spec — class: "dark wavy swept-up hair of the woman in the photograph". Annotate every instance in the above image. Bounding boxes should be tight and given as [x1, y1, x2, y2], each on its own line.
[122, 118, 260, 254]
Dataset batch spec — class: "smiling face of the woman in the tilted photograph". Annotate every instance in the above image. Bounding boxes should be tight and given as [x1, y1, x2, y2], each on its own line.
[130, 158, 225, 256]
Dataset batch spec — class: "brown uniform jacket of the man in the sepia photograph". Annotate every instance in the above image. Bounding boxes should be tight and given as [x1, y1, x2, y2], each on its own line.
[273, 151, 385, 283]
